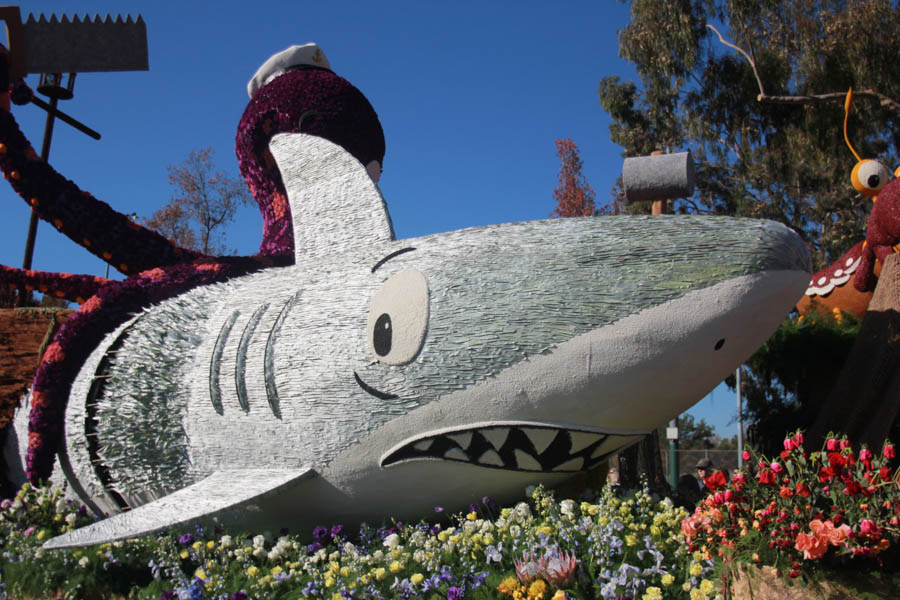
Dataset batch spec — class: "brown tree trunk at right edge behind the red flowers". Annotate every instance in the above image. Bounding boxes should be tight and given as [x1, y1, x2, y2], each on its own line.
[809, 254, 900, 449]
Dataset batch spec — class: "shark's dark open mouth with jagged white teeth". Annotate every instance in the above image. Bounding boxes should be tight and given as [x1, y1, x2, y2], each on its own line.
[381, 423, 647, 473]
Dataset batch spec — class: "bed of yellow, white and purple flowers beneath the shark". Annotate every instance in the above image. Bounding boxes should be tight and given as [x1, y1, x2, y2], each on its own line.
[0, 485, 716, 600]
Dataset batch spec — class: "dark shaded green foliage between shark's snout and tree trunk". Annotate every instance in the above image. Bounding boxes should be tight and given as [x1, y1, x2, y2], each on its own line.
[728, 312, 860, 454]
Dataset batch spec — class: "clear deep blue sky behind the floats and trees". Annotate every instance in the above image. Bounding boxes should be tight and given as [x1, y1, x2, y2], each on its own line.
[0, 0, 735, 435]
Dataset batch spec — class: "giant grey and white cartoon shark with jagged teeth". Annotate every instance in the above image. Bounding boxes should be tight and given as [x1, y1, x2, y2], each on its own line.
[0, 44, 809, 547]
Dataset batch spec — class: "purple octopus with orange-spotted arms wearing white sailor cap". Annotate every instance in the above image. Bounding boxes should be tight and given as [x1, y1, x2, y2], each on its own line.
[0, 44, 385, 483]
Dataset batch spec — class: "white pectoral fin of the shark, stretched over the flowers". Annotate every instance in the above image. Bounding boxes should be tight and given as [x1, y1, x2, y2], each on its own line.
[44, 469, 315, 548]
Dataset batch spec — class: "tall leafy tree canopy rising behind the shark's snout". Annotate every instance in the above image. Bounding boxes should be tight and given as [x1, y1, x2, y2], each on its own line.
[599, 0, 900, 268]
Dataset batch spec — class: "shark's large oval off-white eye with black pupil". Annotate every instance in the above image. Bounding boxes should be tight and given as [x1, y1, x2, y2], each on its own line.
[366, 271, 428, 365]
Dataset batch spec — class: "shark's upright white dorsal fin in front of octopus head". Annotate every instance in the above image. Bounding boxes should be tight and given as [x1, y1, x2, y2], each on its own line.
[269, 133, 394, 263]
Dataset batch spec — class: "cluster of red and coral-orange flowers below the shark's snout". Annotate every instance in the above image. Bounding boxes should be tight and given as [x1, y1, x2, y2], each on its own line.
[682, 432, 900, 597]
